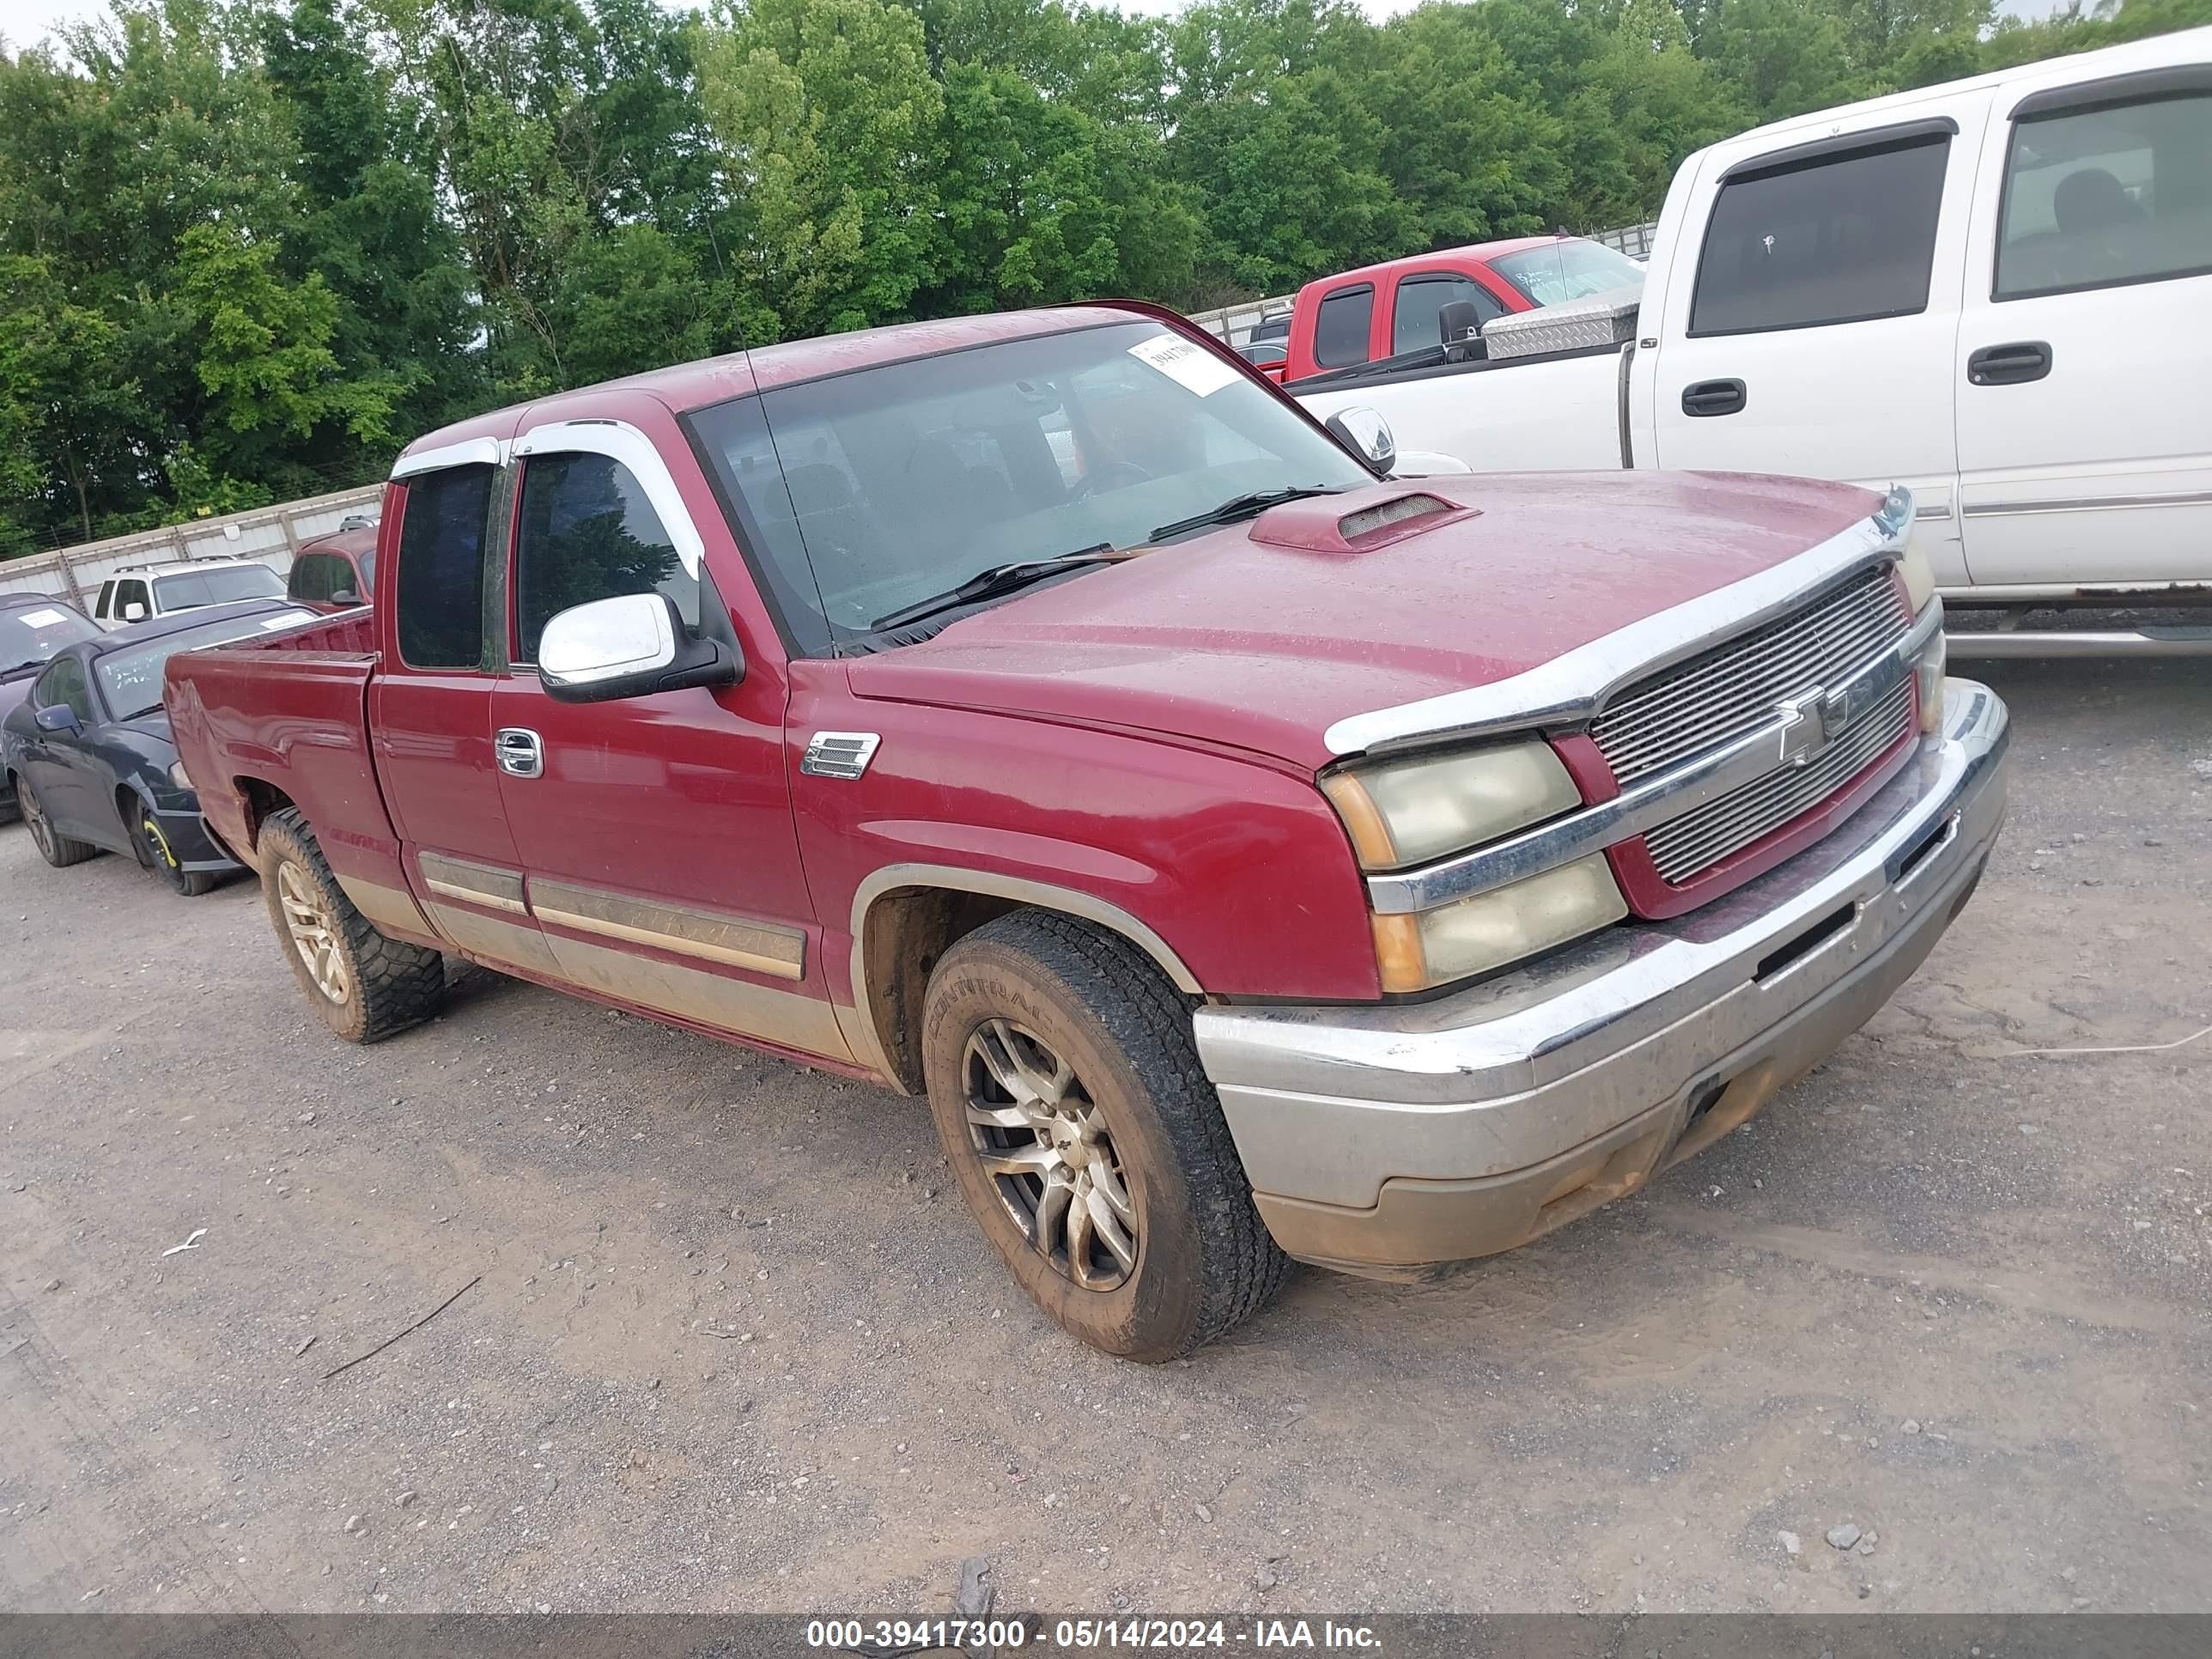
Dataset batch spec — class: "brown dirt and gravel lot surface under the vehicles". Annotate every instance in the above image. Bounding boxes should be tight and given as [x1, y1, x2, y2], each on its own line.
[0, 664, 2212, 1613]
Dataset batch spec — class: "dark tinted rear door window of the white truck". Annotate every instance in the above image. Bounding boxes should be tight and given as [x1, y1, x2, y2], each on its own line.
[1690, 133, 1951, 337]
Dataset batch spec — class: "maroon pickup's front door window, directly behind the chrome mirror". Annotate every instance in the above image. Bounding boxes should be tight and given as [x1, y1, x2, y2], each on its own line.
[513, 453, 699, 661]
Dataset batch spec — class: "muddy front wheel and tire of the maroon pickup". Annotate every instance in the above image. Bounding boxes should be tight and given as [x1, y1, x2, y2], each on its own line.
[922, 909, 1287, 1363]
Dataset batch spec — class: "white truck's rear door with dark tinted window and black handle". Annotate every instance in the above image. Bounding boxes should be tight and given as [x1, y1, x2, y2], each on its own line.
[1637, 91, 1989, 584]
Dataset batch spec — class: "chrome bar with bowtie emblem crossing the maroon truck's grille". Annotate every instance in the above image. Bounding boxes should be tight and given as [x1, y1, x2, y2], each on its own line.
[1367, 599, 1942, 915]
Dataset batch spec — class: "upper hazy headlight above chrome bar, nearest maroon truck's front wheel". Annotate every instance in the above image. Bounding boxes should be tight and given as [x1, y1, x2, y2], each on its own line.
[1321, 744, 1582, 872]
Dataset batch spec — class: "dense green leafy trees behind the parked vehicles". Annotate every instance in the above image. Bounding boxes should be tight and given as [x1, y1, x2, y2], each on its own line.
[0, 0, 2212, 557]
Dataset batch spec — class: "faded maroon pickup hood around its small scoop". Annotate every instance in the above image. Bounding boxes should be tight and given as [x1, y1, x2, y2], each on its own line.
[848, 473, 1881, 769]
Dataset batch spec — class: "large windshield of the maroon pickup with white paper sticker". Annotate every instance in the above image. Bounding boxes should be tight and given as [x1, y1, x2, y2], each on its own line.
[690, 323, 1374, 653]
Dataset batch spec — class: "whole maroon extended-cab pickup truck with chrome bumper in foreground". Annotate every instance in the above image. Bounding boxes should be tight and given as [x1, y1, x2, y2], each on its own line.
[168, 303, 2006, 1360]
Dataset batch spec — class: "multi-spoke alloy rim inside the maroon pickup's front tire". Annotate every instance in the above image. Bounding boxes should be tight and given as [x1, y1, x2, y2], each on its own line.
[960, 1020, 1137, 1290]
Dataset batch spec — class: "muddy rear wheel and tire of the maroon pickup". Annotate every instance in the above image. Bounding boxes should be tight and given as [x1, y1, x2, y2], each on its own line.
[258, 807, 445, 1042]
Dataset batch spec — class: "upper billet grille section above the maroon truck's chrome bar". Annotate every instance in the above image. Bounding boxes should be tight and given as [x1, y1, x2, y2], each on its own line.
[1590, 564, 1911, 787]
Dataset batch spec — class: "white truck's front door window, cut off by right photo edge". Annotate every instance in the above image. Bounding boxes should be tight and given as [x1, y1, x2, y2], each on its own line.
[1990, 93, 2212, 301]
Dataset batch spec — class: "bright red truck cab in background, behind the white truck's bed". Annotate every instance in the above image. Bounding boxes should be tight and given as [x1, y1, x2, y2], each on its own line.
[1270, 237, 1644, 380]
